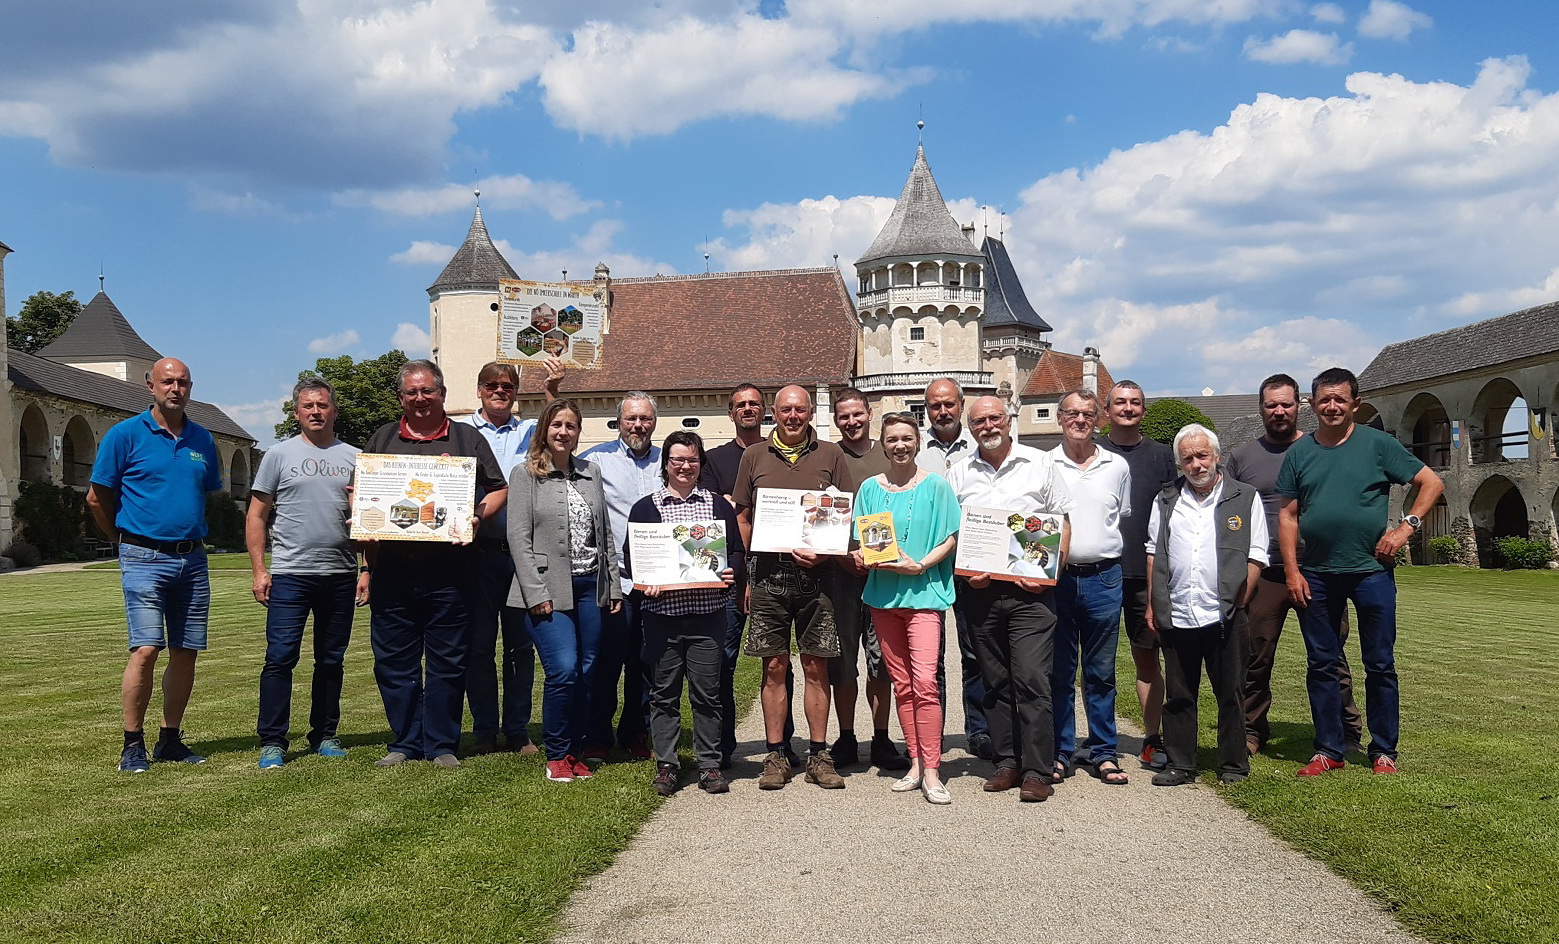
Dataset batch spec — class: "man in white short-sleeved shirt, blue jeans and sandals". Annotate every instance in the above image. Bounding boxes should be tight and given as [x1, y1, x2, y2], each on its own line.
[1049, 389, 1132, 787]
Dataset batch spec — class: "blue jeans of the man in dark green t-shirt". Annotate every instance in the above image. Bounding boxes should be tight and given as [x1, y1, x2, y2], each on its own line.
[1299, 570, 1402, 760]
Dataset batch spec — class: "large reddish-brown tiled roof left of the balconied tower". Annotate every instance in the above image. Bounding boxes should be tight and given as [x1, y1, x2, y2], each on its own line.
[521, 268, 856, 394]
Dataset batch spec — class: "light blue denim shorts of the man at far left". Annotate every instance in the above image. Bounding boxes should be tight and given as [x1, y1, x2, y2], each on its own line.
[118, 541, 210, 650]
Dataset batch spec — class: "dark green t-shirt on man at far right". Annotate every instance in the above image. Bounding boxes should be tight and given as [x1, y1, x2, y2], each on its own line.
[1277, 424, 1423, 573]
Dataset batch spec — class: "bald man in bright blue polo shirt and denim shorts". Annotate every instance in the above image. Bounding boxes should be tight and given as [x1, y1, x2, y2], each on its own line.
[87, 357, 221, 774]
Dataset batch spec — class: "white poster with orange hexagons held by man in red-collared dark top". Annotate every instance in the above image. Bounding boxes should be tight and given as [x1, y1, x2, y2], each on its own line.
[352, 452, 477, 542]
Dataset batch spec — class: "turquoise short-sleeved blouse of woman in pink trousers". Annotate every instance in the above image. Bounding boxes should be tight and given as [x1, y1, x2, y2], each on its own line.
[856, 475, 959, 609]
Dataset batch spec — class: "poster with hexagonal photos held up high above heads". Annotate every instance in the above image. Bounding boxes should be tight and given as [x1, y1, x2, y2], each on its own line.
[497, 279, 606, 371]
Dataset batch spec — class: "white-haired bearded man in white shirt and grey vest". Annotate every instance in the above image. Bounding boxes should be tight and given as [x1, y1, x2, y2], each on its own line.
[1147, 424, 1267, 787]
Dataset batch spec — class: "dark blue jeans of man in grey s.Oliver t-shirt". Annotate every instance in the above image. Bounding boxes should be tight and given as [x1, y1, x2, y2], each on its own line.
[254, 573, 357, 751]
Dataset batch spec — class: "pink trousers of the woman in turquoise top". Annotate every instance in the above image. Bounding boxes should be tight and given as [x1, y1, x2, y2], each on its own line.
[871, 609, 942, 770]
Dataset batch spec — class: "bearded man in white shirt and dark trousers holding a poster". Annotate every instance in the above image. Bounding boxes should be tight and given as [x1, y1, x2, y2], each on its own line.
[948, 397, 1073, 802]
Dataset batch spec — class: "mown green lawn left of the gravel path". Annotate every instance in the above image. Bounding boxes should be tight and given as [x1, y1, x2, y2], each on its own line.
[0, 567, 758, 942]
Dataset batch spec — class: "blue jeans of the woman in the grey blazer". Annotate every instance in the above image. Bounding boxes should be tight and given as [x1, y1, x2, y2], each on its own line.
[530, 573, 602, 760]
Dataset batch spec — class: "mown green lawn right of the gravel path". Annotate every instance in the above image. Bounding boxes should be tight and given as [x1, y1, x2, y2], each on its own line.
[1119, 567, 1559, 944]
